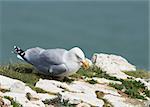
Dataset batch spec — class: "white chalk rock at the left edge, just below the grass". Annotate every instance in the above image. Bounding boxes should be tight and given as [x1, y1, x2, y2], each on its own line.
[0, 75, 25, 89]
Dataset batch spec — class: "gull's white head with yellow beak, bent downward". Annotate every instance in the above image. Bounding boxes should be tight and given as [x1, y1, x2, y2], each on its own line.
[70, 47, 89, 69]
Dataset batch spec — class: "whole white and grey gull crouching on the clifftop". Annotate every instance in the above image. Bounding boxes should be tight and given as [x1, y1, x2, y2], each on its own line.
[14, 46, 89, 77]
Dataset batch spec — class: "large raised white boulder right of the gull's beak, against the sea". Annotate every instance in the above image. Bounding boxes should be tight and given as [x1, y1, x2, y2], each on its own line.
[92, 53, 136, 79]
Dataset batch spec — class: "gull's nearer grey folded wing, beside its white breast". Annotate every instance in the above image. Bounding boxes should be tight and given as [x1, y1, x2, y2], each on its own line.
[38, 49, 67, 76]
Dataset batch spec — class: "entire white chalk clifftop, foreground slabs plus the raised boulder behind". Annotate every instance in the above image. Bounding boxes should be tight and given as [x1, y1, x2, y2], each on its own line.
[0, 54, 150, 107]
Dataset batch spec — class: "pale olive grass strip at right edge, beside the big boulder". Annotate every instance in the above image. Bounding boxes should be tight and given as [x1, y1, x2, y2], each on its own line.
[124, 70, 150, 79]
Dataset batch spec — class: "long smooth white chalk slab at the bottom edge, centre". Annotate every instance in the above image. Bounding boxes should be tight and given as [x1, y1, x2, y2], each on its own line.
[61, 92, 104, 107]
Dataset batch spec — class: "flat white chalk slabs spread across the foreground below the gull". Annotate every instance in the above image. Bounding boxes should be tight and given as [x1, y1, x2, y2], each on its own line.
[0, 76, 147, 107]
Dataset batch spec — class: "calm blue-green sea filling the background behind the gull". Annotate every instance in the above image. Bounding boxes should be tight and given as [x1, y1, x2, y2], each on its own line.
[0, 1, 148, 69]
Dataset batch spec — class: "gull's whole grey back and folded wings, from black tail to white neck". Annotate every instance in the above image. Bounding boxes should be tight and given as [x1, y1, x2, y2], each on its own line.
[25, 47, 67, 76]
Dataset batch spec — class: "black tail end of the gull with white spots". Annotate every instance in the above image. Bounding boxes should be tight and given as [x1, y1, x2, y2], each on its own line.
[14, 46, 26, 60]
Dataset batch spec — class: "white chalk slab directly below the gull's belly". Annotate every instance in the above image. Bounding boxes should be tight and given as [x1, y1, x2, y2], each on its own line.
[35, 79, 64, 94]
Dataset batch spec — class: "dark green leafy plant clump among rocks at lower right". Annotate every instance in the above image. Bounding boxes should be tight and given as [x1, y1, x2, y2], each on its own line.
[109, 79, 150, 100]
